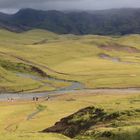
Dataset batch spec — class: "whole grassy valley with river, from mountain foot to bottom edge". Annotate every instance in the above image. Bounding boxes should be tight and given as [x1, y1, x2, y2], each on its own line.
[0, 29, 140, 140]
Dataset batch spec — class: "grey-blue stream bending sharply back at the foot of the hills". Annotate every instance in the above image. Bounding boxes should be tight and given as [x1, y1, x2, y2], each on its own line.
[0, 73, 85, 101]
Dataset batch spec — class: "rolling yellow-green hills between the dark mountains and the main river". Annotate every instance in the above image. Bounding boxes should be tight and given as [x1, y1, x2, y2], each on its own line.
[0, 30, 140, 92]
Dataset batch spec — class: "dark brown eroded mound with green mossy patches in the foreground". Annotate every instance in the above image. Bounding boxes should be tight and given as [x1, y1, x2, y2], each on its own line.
[43, 107, 126, 138]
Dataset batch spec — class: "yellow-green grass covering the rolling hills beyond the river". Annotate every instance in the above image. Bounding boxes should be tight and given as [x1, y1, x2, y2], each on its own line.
[0, 30, 140, 91]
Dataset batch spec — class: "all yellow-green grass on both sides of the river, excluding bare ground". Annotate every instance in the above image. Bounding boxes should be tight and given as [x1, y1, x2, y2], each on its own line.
[0, 30, 140, 140]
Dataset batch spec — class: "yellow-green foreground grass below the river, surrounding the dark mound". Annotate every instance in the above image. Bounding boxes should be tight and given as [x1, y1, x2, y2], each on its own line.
[0, 91, 140, 140]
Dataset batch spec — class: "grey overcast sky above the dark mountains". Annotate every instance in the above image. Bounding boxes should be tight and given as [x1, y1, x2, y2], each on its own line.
[0, 0, 140, 13]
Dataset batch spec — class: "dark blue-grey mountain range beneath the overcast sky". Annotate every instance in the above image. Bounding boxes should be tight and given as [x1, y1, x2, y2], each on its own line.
[0, 9, 140, 35]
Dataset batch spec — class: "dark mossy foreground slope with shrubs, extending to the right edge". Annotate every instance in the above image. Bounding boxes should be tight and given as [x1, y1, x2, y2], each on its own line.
[42, 106, 140, 140]
